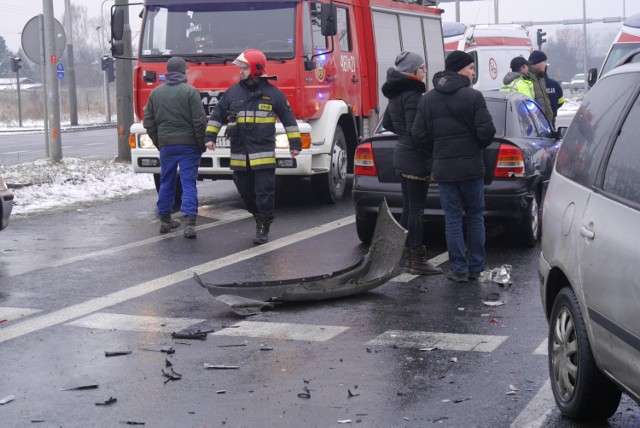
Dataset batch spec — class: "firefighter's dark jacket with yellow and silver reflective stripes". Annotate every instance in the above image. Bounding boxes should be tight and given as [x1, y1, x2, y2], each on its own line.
[205, 78, 302, 171]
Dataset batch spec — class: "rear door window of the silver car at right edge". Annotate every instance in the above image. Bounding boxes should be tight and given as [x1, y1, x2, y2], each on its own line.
[602, 95, 640, 206]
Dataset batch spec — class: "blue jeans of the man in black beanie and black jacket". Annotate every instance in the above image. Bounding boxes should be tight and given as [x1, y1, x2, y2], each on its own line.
[438, 178, 485, 274]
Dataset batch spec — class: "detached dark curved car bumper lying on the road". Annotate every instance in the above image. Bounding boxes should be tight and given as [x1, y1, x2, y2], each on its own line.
[193, 200, 407, 302]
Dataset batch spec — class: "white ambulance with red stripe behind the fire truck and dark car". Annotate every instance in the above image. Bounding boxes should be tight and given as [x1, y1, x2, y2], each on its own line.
[443, 22, 532, 91]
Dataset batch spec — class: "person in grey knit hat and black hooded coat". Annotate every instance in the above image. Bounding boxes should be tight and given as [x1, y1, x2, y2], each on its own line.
[382, 51, 442, 275]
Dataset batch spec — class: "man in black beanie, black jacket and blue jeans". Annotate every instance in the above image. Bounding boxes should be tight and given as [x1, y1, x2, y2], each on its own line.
[411, 51, 496, 282]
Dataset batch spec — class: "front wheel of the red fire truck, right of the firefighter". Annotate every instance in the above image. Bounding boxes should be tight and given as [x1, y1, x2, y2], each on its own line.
[311, 125, 347, 204]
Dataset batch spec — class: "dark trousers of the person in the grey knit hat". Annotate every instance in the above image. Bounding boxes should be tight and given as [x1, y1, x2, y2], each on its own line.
[400, 176, 429, 250]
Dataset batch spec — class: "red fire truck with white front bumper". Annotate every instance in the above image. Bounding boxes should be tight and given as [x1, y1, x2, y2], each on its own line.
[111, 0, 444, 202]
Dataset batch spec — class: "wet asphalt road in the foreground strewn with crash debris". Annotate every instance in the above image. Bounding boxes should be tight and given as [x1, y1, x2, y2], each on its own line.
[0, 182, 640, 427]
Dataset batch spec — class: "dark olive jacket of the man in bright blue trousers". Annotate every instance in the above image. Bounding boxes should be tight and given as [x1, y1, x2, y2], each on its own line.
[142, 73, 207, 152]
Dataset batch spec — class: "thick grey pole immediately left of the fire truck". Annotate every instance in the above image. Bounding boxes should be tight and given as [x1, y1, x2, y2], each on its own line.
[115, 0, 133, 161]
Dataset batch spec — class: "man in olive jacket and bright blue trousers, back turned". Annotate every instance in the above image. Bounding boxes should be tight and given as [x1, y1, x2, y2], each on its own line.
[142, 57, 207, 239]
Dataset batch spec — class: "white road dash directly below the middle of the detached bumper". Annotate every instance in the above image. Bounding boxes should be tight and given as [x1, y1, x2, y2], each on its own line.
[211, 321, 349, 342]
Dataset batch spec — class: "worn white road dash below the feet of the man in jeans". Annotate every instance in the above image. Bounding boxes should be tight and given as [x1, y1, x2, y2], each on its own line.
[366, 330, 508, 352]
